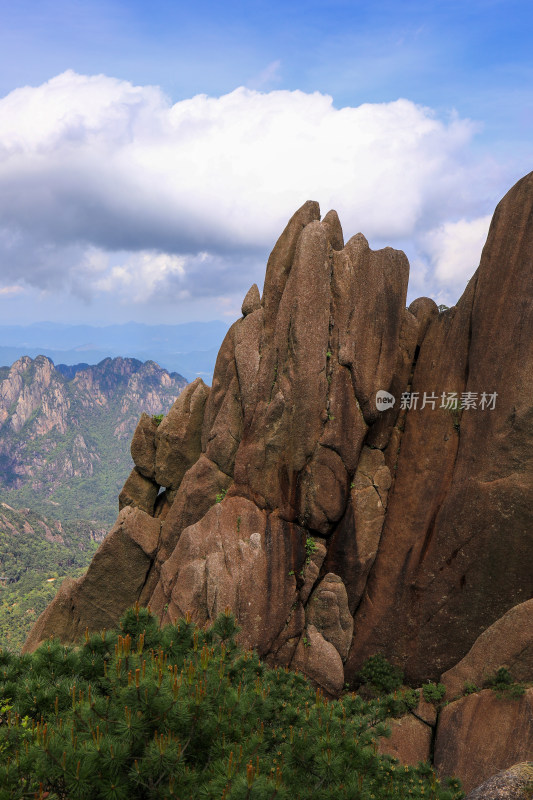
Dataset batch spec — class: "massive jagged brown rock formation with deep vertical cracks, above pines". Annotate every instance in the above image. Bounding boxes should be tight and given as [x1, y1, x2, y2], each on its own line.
[22, 173, 533, 694]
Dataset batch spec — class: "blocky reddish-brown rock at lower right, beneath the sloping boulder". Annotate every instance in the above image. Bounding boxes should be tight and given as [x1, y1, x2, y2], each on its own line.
[435, 689, 533, 792]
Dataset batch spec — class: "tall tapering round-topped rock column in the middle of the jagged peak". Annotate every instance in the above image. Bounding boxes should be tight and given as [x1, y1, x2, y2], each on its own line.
[235, 222, 330, 521]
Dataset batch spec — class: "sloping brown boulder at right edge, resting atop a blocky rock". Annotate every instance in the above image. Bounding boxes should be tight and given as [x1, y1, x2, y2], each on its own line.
[441, 599, 533, 698]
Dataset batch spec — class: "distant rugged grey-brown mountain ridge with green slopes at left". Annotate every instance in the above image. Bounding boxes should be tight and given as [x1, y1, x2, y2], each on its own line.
[0, 355, 187, 524]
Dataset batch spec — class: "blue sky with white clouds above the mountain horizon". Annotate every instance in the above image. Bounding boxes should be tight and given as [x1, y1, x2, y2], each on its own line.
[0, 0, 533, 324]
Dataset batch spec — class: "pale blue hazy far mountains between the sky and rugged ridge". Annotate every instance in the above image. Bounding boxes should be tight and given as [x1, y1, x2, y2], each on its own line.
[0, 320, 228, 384]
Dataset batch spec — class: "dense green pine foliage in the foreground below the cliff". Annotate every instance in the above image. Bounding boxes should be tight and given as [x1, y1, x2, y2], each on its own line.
[0, 606, 464, 800]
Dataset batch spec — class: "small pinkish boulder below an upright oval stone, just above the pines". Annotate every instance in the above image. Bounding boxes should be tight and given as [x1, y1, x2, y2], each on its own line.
[291, 625, 344, 696]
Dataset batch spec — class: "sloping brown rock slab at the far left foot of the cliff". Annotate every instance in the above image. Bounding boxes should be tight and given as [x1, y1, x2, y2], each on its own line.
[23, 507, 161, 653]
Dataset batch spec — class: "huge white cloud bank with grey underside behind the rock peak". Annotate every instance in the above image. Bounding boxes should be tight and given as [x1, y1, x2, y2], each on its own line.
[0, 69, 502, 302]
